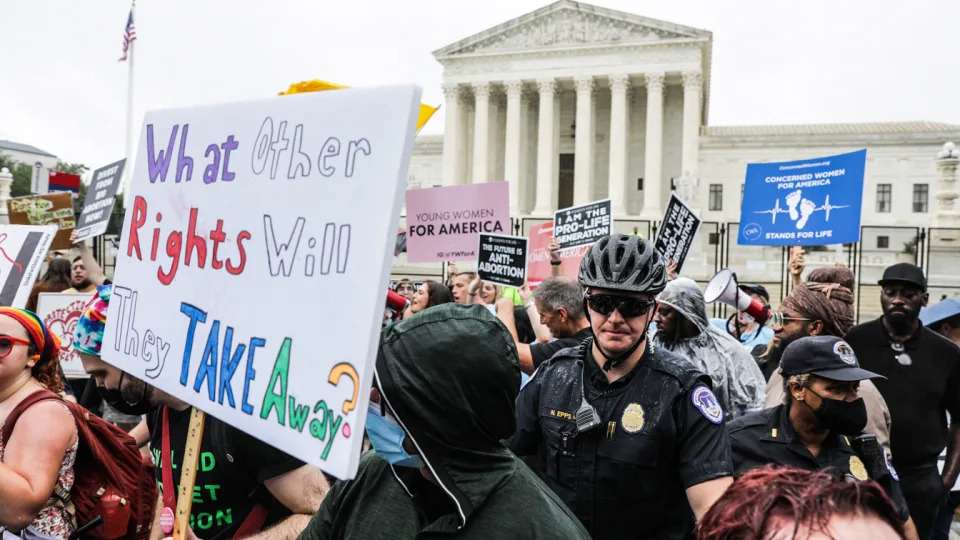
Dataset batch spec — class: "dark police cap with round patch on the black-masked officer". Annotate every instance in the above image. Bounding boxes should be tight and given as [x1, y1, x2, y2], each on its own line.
[780, 336, 886, 381]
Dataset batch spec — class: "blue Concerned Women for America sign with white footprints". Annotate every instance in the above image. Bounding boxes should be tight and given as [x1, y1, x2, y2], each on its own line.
[737, 150, 867, 246]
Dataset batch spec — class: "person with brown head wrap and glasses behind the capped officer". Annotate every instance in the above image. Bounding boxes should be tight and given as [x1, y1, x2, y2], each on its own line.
[764, 266, 891, 451]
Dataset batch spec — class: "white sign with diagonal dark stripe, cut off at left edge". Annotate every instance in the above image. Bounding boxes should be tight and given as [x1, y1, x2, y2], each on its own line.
[0, 225, 57, 308]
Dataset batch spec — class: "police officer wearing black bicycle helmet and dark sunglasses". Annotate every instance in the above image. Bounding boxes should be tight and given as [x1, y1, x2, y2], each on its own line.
[510, 234, 733, 540]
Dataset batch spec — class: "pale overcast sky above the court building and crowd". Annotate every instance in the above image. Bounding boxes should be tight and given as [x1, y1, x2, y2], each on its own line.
[0, 0, 960, 173]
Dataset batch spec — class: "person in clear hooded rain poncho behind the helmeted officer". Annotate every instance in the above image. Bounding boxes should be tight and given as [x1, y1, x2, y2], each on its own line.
[653, 278, 766, 418]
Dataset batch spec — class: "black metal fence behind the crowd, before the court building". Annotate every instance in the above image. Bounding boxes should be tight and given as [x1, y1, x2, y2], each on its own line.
[93, 213, 960, 322]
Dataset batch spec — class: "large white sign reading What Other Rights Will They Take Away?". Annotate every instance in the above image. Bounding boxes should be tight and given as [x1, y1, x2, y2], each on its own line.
[102, 86, 420, 478]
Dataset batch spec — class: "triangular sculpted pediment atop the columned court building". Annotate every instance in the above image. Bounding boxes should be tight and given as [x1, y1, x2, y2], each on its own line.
[433, 0, 711, 61]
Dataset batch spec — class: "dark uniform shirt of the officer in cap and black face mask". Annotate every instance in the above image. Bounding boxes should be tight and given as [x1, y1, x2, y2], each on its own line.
[727, 405, 909, 521]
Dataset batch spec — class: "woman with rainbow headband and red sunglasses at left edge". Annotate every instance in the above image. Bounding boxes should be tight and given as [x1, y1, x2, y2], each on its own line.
[0, 307, 79, 539]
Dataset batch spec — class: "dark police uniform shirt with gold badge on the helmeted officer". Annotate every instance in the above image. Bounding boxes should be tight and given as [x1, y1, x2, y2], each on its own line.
[509, 339, 733, 540]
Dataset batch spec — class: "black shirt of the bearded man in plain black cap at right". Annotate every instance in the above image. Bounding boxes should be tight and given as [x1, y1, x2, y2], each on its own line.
[845, 319, 960, 472]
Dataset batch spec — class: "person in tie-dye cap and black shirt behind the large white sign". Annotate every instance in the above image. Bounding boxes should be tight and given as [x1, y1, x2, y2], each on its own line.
[75, 286, 329, 538]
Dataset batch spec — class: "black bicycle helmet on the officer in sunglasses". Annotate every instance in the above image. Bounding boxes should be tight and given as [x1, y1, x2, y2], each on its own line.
[578, 233, 667, 295]
